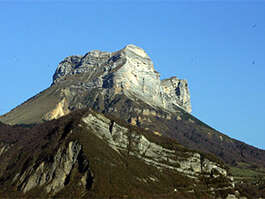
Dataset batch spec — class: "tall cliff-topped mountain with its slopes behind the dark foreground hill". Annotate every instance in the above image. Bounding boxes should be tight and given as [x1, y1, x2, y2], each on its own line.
[0, 45, 265, 179]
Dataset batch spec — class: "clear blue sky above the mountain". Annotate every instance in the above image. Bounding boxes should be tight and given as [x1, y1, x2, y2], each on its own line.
[0, 0, 265, 149]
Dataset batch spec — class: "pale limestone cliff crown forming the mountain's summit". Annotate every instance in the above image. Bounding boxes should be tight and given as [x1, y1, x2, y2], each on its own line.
[53, 45, 191, 112]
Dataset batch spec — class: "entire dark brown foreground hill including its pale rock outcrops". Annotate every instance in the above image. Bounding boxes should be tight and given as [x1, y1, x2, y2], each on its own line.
[0, 110, 241, 199]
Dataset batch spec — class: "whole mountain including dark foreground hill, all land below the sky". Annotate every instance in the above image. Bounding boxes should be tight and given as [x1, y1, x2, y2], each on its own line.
[0, 45, 265, 198]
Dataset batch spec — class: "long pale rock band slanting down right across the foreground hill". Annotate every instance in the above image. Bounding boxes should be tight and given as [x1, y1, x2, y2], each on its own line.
[82, 114, 232, 182]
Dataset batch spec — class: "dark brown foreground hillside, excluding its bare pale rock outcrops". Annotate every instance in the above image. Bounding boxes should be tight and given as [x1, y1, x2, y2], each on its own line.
[0, 109, 241, 199]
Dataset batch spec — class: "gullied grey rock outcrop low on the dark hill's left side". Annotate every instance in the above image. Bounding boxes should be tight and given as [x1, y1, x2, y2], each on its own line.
[13, 141, 81, 194]
